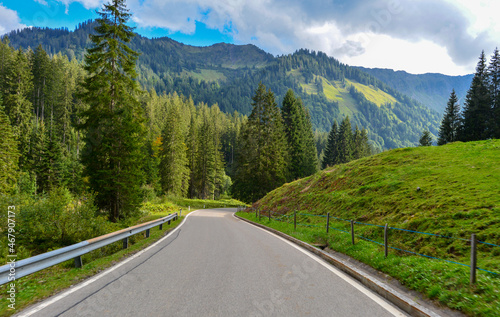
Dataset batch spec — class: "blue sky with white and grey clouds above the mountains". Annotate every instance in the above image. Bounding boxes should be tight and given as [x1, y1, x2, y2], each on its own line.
[0, 0, 500, 75]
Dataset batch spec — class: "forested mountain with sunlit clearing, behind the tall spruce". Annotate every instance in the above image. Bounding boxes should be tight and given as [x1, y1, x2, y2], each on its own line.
[4, 21, 442, 149]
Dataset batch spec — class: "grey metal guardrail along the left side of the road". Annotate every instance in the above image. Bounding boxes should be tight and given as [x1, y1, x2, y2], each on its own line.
[0, 213, 179, 285]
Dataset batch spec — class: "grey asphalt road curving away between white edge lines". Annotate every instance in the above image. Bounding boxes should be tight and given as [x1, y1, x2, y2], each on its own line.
[20, 209, 406, 317]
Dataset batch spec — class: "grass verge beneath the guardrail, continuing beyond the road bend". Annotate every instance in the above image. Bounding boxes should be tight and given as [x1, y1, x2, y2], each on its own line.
[0, 197, 244, 317]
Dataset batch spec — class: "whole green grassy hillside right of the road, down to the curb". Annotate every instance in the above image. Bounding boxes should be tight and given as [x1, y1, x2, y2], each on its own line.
[245, 140, 500, 316]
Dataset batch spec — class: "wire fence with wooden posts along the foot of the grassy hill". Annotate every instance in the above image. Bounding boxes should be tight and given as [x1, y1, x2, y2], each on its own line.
[238, 208, 500, 284]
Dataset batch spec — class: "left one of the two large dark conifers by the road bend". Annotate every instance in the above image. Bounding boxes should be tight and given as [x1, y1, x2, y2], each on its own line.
[233, 83, 288, 202]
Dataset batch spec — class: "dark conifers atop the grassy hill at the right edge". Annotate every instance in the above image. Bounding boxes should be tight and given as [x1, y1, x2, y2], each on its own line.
[437, 48, 500, 145]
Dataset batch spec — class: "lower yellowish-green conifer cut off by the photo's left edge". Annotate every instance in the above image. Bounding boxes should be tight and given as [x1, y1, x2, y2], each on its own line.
[0, 105, 19, 194]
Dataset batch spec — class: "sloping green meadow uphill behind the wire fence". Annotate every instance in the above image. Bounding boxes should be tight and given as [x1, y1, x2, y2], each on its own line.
[258, 140, 500, 266]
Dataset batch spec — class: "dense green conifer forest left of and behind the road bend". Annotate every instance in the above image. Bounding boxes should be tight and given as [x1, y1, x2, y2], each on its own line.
[0, 1, 318, 235]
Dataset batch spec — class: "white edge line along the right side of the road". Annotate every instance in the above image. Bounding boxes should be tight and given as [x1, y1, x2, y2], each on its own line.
[233, 213, 408, 317]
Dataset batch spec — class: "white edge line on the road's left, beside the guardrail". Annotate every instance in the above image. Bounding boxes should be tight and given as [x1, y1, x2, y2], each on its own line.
[18, 211, 197, 317]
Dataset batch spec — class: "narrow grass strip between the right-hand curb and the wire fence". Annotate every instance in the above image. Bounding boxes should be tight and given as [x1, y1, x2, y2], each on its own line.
[237, 212, 500, 317]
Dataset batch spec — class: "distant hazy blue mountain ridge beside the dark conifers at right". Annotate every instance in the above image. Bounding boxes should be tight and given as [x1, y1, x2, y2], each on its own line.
[357, 67, 474, 113]
